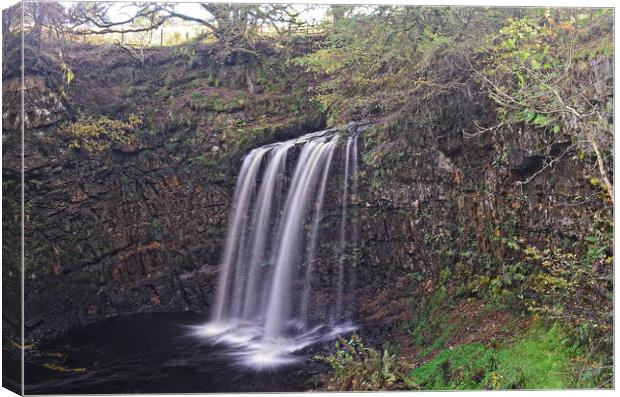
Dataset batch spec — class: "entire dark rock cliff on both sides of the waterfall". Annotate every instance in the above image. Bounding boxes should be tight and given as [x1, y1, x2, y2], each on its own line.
[3, 41, 612, 338]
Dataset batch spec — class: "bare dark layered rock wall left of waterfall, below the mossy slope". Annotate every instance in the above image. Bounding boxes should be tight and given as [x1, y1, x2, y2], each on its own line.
[4, 76, 230, 336]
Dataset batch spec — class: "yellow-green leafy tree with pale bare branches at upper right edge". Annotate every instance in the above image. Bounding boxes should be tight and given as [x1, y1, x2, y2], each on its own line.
[480, 9, 613, 202]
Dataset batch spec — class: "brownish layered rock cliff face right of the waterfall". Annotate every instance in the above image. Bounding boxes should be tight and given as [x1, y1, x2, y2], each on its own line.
[344, 60, 611, 328]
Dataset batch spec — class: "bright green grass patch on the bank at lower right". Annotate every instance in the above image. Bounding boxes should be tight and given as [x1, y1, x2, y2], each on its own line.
[407, 325, 577, 390]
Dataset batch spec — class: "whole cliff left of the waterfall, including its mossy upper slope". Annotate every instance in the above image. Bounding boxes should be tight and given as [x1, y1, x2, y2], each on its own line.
[3, 43, 322, 339]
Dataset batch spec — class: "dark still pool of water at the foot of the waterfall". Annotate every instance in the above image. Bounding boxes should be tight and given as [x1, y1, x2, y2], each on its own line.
[25, 313, 333, 394]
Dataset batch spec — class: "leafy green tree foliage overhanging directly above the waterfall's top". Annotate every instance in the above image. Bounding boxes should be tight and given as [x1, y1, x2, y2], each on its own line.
[297, 7, 514, 122]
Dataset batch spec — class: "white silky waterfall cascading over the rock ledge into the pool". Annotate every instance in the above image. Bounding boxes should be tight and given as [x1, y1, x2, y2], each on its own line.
[194, 130, 358, 367]
